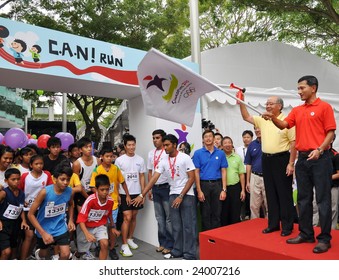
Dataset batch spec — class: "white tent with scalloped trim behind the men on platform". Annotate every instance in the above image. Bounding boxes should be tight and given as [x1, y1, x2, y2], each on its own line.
[201, 42, 339, 148]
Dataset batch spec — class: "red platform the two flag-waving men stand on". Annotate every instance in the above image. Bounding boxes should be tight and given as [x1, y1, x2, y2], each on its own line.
[199, 219, 339, 260]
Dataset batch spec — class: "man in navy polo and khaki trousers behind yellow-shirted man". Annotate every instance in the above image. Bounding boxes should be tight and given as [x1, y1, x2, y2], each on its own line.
[245, 127, 267, 219]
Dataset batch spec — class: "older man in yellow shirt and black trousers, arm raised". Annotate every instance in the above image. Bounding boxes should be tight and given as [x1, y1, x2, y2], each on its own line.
[240, 96, 296, 236]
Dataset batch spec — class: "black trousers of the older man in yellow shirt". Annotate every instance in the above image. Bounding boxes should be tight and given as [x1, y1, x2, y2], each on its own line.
[262, 152, 295, 230]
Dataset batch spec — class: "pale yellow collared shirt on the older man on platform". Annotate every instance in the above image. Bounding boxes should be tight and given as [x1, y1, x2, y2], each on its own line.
[253, 114, 295, 154]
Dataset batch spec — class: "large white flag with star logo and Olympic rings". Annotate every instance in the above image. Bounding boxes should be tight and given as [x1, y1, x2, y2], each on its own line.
[137, 49, 221, 126]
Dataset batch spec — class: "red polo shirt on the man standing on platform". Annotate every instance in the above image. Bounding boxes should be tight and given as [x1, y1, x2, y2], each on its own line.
[285, 98, 336, 151]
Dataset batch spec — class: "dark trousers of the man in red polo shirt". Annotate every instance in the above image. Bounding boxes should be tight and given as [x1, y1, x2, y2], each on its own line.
[295, 151, 333, 243]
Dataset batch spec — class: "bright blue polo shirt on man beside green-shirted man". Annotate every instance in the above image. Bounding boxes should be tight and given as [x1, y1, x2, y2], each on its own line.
[193, 147, 228, 180]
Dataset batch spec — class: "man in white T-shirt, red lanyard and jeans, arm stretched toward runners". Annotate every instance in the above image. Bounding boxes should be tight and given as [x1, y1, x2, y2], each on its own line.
[132, 134, 197, 260]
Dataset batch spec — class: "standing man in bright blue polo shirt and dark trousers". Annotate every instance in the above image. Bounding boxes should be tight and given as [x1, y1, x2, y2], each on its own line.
[193, 130, 228, 231]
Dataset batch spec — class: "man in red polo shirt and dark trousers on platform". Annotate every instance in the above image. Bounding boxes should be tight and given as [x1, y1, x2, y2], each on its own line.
[262, 76, 336, 253]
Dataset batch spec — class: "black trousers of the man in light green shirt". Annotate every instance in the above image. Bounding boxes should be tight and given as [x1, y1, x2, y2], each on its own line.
[220, 183, 241, 226]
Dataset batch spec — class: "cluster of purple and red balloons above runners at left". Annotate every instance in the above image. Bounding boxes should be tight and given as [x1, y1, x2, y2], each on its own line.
[0, 128, 74, 150]
